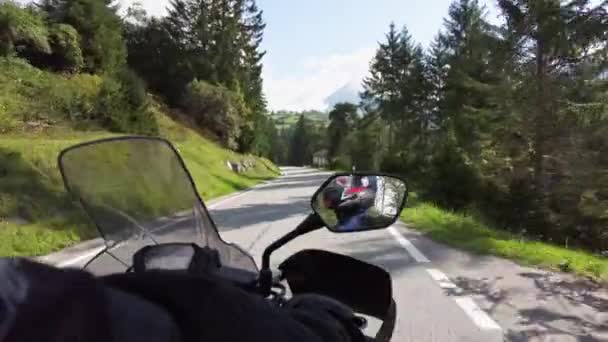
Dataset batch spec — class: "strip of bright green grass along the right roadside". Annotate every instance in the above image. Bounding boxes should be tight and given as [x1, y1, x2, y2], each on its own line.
[401, 203, 608, 282]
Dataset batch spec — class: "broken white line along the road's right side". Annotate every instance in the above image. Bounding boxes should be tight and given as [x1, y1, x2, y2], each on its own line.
[388, 226, 502, 331]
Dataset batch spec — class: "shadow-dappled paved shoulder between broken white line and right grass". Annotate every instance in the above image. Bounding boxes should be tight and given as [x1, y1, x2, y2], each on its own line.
[400, 227, 608, 341]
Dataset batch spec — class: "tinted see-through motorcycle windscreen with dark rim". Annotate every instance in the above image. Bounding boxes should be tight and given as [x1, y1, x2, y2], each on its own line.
[59, 138, 256, 270]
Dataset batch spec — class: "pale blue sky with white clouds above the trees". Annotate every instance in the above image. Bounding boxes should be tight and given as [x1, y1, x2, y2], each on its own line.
[121, 0, 496, 110]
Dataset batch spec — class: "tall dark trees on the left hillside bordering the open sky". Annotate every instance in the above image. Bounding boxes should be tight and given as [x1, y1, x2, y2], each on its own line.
[125, 0, 266, 151]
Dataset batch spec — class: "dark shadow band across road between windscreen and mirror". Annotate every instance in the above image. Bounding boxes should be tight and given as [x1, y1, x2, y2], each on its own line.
[211, 196, 310, 233]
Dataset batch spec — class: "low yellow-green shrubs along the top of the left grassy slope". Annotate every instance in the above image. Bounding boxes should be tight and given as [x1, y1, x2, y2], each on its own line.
[0, 58, 158, 134]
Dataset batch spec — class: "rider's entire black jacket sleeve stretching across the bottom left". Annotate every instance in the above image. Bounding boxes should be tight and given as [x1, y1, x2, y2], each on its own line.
[0, 258, 353, 342]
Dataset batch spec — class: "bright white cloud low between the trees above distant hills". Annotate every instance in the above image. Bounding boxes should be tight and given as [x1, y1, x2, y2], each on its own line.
[264, 48, 375, 110]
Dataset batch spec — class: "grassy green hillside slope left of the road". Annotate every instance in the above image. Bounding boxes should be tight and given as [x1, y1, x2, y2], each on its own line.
[0, 61, 278, 256]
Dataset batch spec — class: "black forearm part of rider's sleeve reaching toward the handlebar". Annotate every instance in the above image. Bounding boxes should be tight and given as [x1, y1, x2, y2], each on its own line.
[104, 272, 351, 342]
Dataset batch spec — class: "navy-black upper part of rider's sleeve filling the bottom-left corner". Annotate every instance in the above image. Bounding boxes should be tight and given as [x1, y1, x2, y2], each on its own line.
[0, 258, 179, 342]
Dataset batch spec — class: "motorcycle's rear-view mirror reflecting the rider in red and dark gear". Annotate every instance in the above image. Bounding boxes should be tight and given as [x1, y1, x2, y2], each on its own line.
[312, 174, 407, 232]
